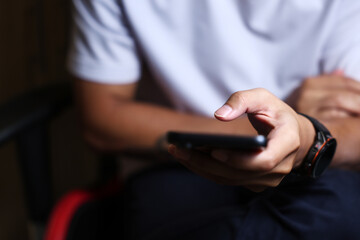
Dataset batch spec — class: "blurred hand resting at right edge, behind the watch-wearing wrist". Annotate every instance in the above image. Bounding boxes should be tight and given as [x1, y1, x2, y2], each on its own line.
[287, 70, 360, 121]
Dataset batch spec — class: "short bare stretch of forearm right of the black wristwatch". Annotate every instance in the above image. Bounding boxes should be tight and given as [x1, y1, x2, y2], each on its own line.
[323, 117, 360, 169]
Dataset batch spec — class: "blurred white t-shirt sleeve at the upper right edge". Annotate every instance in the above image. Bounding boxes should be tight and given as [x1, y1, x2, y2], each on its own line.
[322, 0, 360, 81]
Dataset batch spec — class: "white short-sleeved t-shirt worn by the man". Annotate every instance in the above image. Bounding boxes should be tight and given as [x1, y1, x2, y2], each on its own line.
[68, 0, 360, 116]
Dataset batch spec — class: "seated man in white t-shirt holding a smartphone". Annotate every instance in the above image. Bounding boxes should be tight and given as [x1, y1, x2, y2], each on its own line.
[69, 0, 360, 239]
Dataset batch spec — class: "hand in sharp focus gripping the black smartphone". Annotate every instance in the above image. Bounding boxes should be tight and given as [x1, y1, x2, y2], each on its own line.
[169, 89, 315, 191]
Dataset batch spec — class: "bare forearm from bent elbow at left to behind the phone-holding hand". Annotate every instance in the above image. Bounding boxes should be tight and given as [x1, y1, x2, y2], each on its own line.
[79, 96, 255, 151]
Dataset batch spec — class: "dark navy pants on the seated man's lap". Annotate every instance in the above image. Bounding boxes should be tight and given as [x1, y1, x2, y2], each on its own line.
[125, 166, 360, 240]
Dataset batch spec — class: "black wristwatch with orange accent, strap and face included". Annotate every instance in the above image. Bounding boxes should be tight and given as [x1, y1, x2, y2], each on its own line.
[296, 113, 336, 178]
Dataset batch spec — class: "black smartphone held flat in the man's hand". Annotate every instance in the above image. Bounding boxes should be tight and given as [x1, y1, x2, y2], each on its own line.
[167, 131, 267, 151]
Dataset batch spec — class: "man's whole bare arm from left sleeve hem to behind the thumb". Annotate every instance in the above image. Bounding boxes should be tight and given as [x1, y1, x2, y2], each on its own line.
[74, 79, 256, 151]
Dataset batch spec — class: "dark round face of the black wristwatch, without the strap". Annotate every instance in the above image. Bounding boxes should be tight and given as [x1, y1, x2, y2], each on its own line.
[312, 138, 336, 177]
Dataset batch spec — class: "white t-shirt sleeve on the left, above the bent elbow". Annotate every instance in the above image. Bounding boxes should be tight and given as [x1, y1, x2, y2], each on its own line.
[67, 0, 141, 84]
